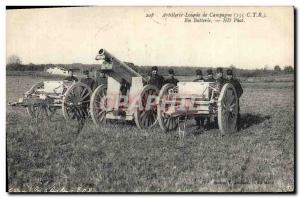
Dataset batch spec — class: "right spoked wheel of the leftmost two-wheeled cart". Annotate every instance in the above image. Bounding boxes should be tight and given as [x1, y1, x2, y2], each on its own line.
[62, 82, 92, 121]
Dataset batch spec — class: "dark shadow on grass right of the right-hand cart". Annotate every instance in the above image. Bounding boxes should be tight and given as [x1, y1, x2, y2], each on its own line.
[238, 113, 271, 130]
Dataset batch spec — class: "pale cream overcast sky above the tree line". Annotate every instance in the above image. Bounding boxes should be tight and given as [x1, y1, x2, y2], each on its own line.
[6, 7, 294, 68]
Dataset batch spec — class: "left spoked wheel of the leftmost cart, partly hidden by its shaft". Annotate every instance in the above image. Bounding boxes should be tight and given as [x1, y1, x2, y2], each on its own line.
[25, 82, 56, 122]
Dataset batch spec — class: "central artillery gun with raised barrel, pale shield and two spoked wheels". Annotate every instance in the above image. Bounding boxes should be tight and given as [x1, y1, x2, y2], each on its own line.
[90, 49, 159, 129]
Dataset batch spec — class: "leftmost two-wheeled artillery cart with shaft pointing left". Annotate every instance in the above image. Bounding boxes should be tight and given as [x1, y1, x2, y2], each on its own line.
[9, 81, 92, 122]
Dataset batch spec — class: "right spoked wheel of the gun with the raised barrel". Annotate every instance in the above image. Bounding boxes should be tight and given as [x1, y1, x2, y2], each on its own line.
[134, 85, 159, 129]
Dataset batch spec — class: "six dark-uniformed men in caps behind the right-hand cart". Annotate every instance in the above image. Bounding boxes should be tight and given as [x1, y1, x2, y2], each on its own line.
[148, 67, 243, 131]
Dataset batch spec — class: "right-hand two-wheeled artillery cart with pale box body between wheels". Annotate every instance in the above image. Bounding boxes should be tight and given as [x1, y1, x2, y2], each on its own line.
[157, 82, 239, 134]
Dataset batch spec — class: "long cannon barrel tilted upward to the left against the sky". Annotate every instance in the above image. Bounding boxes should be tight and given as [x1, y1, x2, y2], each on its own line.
[96, 49, 146, 83]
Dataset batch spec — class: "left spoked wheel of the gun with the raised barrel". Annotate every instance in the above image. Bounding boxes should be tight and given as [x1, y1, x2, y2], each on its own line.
[90, 85, 107, 127]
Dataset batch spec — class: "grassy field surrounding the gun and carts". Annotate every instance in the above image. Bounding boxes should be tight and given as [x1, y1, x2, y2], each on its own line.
[6, 76, 295, 192]
